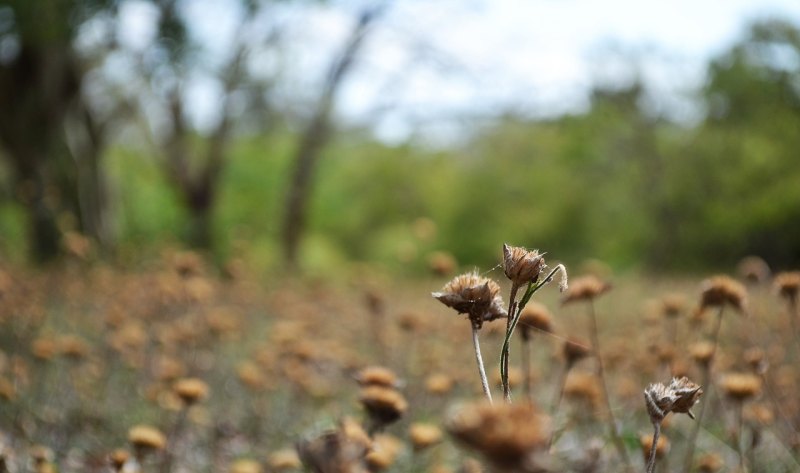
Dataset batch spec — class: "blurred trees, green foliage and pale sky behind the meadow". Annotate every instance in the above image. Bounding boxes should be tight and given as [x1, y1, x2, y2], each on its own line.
[0, 0, 800, 275]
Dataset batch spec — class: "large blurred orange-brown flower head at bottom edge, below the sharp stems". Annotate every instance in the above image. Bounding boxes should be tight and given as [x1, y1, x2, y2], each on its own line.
[445, 403, 550, 471]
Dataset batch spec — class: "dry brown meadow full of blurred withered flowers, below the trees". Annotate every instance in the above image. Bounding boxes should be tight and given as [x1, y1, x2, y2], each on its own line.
[0, 253, 800, 472]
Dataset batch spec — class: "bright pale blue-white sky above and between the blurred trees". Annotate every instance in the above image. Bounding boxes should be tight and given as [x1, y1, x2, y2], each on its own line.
[120, 0, 800, 141]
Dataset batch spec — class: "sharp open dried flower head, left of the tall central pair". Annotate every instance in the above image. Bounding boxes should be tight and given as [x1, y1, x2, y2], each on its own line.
[431, 271, 508, 328]
